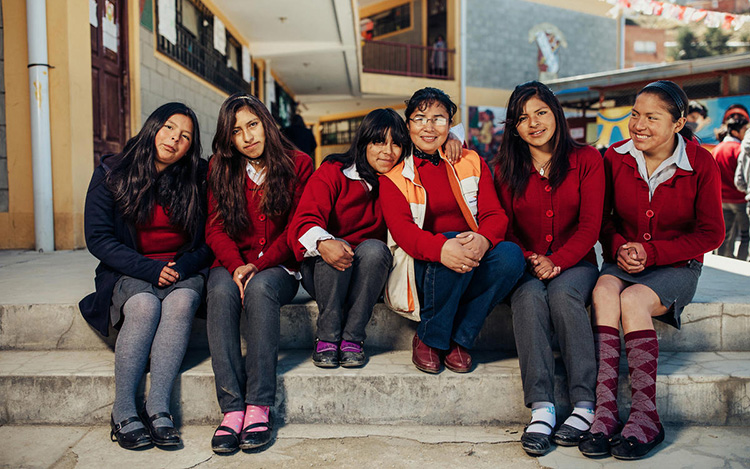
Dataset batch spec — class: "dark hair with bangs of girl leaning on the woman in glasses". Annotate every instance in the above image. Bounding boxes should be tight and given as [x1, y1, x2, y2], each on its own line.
[323, 108, 411, 197]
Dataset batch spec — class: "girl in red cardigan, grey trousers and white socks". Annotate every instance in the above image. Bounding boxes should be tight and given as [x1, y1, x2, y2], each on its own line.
[495, 81, 604, 456]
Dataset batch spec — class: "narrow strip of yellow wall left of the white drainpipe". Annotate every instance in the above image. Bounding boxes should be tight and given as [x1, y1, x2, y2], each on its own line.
[0, 0, 34, 249]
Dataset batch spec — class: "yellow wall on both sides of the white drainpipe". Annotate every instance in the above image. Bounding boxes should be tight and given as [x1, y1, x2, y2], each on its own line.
[0, 0, 93, 249]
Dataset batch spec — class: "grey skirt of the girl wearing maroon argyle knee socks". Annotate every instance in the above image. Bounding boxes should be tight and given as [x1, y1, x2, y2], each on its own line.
[599, 259, 703, 329]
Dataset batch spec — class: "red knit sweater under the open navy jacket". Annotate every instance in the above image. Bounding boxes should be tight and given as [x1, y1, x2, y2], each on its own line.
[136, 204, 190, 262]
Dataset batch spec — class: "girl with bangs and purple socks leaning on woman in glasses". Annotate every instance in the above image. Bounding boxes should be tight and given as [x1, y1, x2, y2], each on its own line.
[289, 109, 410, 368]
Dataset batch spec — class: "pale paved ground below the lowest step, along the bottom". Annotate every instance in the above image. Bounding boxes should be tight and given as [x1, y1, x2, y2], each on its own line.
[0, 425, 750, 469]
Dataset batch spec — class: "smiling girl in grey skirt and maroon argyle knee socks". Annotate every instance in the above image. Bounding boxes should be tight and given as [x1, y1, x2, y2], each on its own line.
[578, 80, 724, 459]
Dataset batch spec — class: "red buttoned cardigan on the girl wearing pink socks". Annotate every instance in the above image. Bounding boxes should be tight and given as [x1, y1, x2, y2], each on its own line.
[206, 151, 313, 274]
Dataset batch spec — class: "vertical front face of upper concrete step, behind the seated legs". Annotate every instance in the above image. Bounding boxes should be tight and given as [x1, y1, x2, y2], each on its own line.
[0, 298, 750, 352]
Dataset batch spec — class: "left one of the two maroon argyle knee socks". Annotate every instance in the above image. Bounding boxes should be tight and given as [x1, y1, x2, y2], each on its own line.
[590, 326, 620, 437]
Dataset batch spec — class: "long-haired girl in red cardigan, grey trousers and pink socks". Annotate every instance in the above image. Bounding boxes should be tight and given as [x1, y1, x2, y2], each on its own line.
[206, 93, 312, 453]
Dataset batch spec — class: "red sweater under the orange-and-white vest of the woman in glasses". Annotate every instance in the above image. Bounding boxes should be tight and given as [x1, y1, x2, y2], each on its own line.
[380, 158, 508, 262]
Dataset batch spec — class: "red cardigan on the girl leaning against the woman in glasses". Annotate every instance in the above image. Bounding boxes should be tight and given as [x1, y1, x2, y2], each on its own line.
[289, 162, 386, 261]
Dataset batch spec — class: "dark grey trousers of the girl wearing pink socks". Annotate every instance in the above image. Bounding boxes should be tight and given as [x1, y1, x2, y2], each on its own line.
[206, 267, 299, 413]
